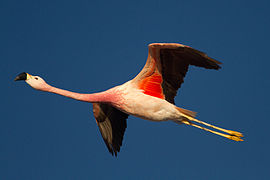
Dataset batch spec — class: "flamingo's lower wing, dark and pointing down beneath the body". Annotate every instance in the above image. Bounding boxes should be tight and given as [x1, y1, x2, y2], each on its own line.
[93, 103, 128, 156]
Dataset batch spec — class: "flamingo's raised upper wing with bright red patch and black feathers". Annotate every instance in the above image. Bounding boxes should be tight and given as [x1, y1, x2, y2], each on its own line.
[133, 43, 221, 104]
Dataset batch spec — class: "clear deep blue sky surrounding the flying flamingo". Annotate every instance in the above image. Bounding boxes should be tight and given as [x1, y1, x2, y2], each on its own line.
[0, 0, 270, 180]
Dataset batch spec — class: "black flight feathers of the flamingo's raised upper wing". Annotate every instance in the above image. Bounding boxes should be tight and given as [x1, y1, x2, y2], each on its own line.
[160, 46, 221, 104]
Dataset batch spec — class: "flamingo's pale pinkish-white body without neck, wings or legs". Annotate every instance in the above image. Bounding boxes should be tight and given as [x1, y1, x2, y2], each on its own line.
[109, 81, 181, 121]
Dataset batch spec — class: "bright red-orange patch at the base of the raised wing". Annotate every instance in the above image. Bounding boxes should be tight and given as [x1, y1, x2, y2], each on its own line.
[139, 72, 164, 99]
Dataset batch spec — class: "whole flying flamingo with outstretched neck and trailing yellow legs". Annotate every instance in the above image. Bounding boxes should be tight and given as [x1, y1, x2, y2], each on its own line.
[14, 43, 243, 156]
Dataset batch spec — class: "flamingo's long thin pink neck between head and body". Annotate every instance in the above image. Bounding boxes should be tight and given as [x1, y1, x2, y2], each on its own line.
[46, 86, 113, 102]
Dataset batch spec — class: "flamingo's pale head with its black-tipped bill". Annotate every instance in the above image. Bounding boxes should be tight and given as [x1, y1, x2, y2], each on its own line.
[14, 72, 50, 91]
